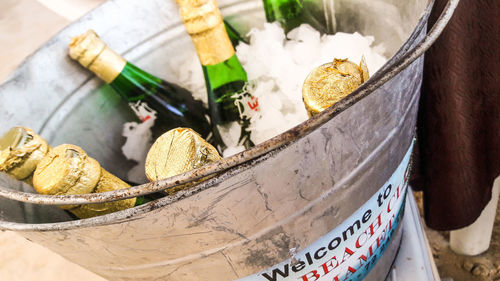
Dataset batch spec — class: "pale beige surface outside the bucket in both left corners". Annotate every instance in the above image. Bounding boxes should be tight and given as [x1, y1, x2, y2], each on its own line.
[0, 0, 104, 281]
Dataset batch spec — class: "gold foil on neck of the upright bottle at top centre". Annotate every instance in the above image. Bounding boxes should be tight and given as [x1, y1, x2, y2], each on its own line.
[177, 0, 234, 65]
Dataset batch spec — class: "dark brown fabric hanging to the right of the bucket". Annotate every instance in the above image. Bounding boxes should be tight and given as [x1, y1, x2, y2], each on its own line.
[412, 0, 500, 230]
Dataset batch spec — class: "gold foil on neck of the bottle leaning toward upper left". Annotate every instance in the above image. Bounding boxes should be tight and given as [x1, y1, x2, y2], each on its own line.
[69, 30, 127, 84]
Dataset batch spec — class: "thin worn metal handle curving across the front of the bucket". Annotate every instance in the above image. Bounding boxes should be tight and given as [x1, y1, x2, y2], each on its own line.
[0, 0, 460, 205]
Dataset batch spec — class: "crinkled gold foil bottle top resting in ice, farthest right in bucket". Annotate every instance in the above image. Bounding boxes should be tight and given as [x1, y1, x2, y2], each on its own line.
[302, 57, 369, 116]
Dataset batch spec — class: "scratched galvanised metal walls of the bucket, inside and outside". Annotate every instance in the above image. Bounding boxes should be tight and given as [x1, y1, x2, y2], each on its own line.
[0, 0, 432, 280]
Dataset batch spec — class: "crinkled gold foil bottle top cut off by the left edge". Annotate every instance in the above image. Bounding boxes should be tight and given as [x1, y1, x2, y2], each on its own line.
[0, 127, 50, 180]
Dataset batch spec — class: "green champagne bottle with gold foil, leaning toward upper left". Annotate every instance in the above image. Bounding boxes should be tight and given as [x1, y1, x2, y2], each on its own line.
[69, 30, 210, 138]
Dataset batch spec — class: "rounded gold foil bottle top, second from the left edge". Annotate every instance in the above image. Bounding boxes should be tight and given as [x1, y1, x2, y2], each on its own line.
[33, 144, 101, 197]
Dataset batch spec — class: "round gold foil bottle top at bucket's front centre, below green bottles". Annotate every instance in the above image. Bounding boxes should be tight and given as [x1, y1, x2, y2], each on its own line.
[146, 128, 222, 181]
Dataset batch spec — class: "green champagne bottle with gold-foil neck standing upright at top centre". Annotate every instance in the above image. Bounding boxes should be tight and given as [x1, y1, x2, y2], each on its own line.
[177, 0, 259, 151]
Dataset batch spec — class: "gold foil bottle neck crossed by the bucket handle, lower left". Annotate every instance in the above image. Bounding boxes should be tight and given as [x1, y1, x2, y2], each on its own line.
[70, 168, 136, 219]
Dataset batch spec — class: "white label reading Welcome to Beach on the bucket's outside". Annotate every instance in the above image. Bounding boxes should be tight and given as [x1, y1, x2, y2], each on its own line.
[239, 144, 413, 281]
